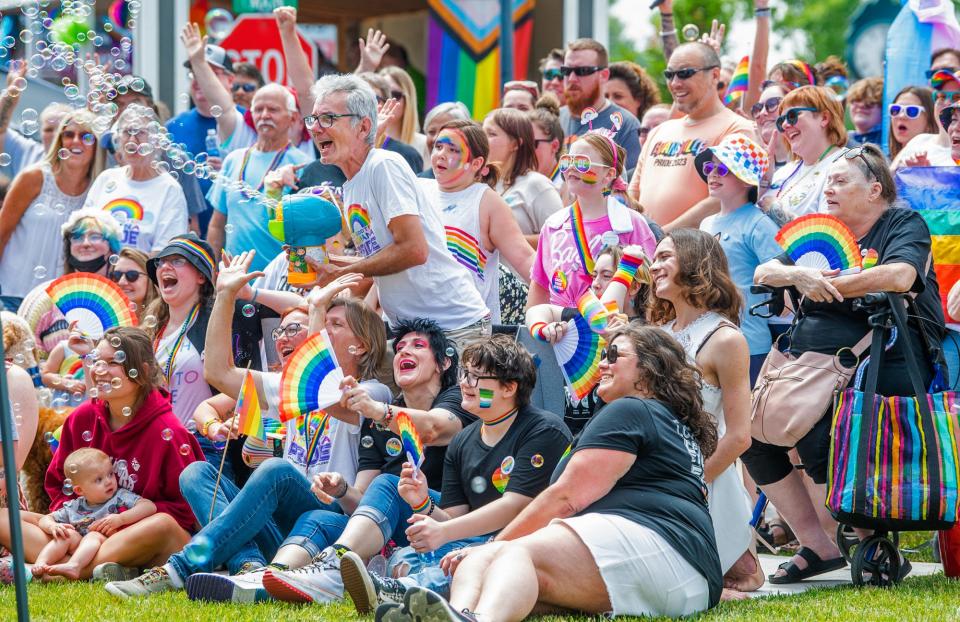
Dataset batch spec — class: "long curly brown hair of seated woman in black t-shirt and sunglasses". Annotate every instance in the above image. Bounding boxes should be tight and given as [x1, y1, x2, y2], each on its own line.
[609, 323, 717, 459]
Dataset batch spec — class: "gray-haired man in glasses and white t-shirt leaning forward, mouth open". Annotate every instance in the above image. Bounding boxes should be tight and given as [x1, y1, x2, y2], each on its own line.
[304, 75, 490, 348]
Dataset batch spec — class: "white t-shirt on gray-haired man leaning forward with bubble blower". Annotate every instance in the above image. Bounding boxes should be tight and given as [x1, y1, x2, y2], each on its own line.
[343, 149, 489, 330]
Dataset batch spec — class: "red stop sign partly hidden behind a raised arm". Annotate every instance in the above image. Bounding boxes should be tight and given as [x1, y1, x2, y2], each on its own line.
[220, 13, 317, 86]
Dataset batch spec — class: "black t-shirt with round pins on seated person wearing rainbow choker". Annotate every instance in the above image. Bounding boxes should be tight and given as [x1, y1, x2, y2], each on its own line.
[440, 406, 571, 510]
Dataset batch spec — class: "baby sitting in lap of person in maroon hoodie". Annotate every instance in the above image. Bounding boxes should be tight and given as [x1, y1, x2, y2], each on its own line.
[32, 447, 157, 579]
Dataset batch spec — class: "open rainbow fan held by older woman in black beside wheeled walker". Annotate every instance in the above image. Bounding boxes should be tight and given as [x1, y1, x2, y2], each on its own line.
[776, 214, 861, 274]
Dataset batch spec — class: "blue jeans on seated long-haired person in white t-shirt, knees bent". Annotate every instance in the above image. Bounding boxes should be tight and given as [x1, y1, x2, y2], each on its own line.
[169, 458, 338, 578]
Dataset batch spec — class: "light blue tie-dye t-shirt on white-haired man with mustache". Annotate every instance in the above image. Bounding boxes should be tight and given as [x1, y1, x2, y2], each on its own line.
[207, 147, 309, 270]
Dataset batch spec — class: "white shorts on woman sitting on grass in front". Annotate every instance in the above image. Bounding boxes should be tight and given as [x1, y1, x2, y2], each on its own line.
[551, 513, 710, 618]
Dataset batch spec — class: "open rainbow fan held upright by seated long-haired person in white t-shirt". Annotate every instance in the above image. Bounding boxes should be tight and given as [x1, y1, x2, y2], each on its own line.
[279, 331, 343, 421]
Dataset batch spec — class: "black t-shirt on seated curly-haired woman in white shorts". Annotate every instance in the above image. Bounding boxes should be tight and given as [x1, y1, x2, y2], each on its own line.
[551, 397, 723, 606]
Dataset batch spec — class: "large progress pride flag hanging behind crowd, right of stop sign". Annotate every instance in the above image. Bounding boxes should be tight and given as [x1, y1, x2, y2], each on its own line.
[426, 0, 535, 119]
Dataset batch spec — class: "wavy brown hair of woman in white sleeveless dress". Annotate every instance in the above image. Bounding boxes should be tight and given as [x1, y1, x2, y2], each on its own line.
[647, 228, 743, 326]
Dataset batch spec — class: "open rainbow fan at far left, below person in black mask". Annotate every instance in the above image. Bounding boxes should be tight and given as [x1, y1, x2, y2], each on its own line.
[47, 272, 137, 338]
